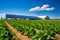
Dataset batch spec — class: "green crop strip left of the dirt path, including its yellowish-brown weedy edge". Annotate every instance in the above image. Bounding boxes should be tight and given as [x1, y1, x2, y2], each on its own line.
[0, 20, 21, 40]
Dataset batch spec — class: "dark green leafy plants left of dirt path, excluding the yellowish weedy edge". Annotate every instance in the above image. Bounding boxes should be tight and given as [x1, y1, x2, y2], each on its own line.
[0, 20, 12, 40]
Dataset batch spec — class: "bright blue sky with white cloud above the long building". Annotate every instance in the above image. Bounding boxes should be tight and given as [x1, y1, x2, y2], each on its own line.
[0, 0, 60, 18]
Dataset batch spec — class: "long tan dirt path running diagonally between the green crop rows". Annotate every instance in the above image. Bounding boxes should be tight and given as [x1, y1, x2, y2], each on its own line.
[4, 21, 31, 40]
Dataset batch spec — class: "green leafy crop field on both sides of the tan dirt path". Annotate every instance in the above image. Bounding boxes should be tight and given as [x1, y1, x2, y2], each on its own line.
[0, 20, 60, 40]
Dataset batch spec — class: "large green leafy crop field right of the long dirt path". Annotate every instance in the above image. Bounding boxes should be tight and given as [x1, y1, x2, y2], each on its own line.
[6, 20, 60, 40]
